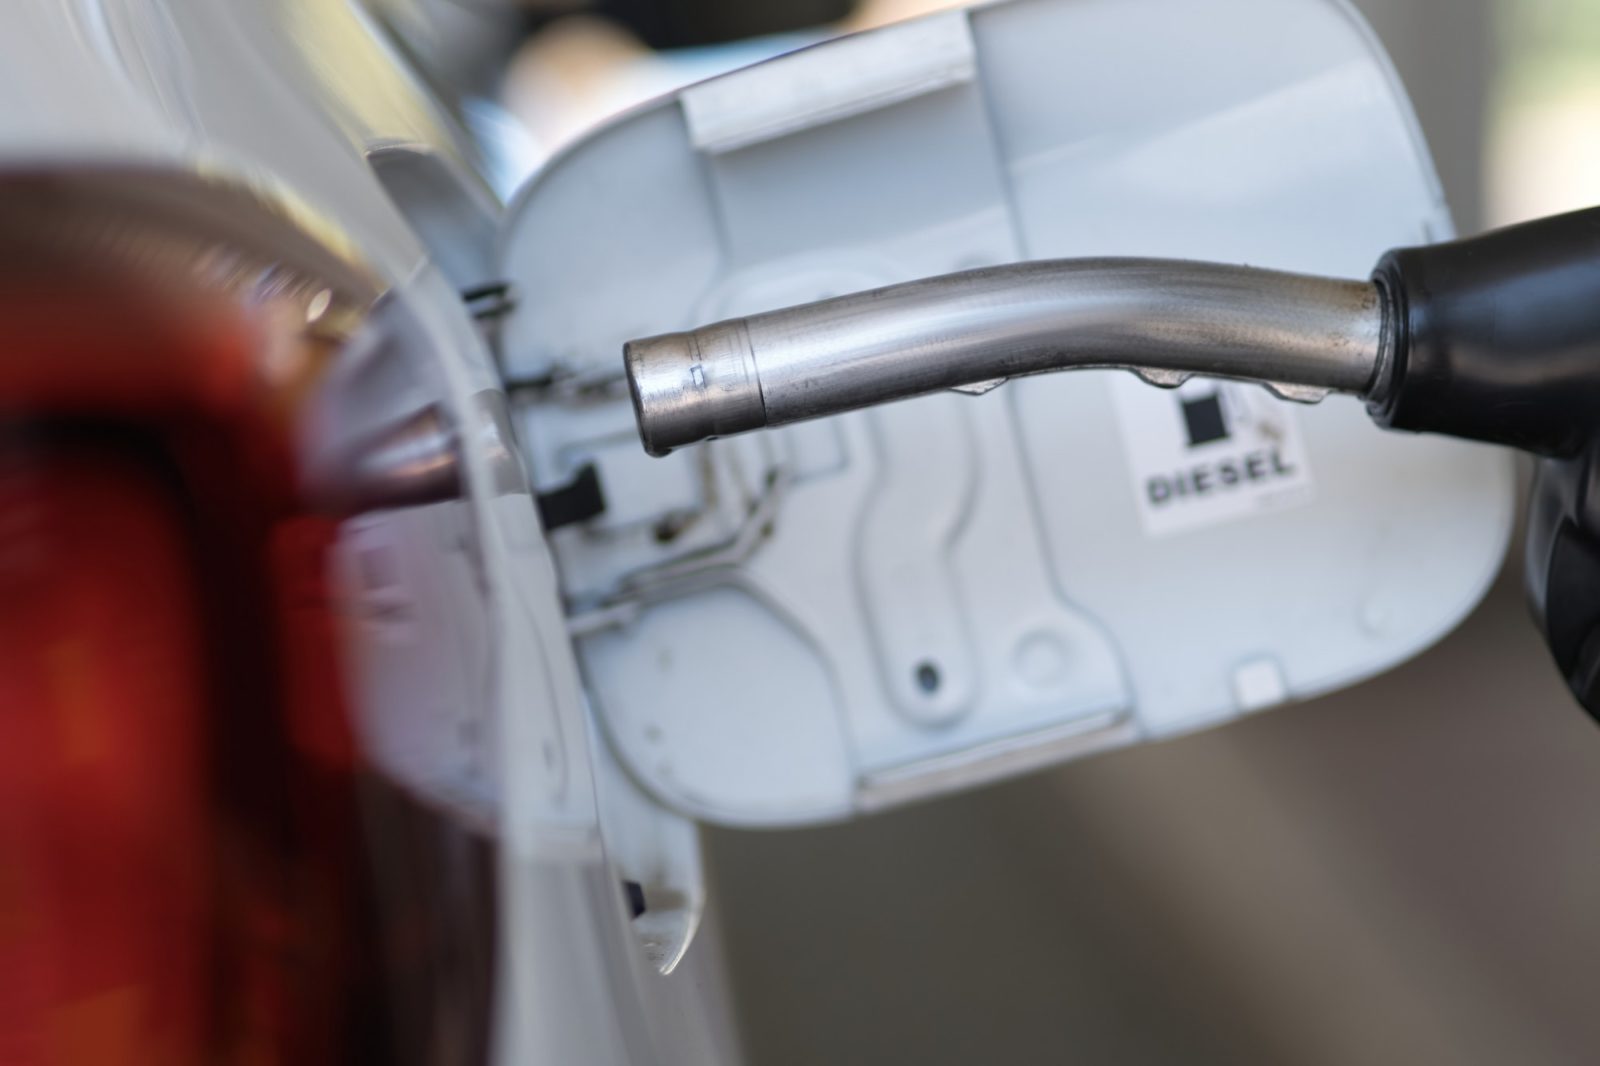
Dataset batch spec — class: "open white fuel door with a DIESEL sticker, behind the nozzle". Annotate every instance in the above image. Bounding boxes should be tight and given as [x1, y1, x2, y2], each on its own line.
[501, 0, 1512, 826]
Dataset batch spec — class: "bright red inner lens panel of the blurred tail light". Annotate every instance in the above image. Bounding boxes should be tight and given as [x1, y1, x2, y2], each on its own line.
[0, 443, 212, 1064]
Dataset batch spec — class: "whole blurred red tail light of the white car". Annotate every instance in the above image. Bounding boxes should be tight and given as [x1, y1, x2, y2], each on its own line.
[0, 228, 371, 1066]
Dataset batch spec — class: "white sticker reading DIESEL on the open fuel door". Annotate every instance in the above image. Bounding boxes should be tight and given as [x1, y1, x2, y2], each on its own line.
[1109, 373, 1312, 536]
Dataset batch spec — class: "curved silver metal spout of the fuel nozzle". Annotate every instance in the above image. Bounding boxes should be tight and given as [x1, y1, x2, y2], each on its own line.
[624, 259, 1386, 455]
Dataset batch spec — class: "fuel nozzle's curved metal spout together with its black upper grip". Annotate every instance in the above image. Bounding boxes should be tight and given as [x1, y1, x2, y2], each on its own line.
[624, 210, 1600, 455]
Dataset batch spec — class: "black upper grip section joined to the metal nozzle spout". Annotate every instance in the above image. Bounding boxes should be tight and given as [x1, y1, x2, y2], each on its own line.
[1368, 208, 1600, 456]
